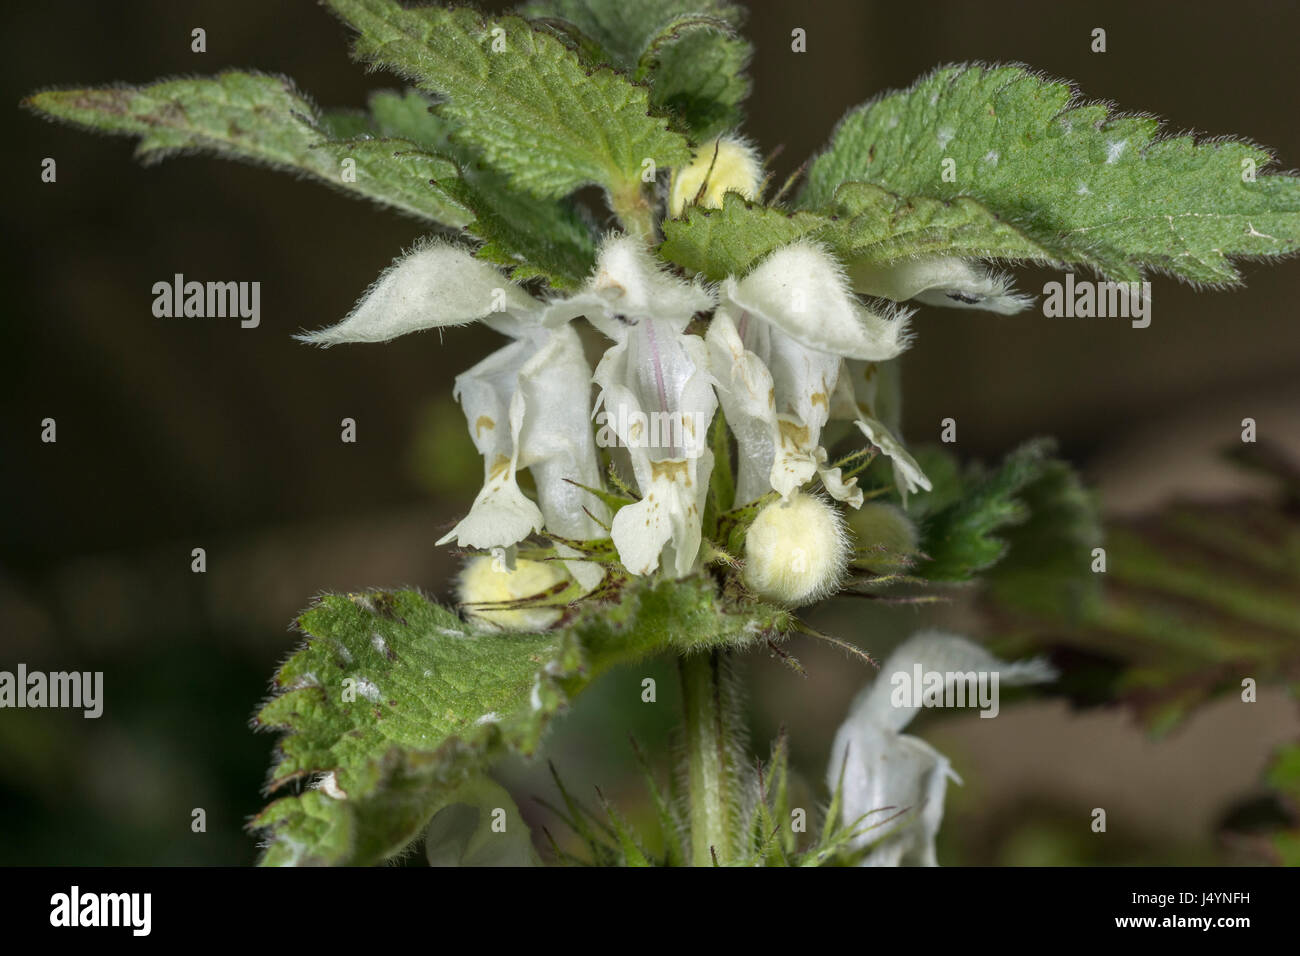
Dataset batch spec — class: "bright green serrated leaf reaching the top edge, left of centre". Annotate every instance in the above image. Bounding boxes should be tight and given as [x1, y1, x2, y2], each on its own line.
[328, 0, 689, 198]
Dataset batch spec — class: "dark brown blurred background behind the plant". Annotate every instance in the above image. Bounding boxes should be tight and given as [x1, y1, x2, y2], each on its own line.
[0, 0, 1300, 864]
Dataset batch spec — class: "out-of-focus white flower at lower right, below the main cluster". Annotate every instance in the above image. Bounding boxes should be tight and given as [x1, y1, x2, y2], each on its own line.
[827, 631, 1056, 866]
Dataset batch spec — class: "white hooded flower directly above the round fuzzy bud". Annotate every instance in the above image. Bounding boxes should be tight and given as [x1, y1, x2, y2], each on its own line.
[707, 242, 907, 507]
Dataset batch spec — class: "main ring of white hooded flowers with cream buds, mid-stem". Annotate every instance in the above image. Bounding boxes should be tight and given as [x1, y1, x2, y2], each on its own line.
[302, 139, 1029, 604]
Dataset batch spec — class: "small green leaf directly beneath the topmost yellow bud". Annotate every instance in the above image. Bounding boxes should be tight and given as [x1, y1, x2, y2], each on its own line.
[659, 193, 829, 281]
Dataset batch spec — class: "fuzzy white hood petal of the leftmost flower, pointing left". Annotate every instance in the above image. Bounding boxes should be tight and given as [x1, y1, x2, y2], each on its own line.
[298, 242, 540, 346]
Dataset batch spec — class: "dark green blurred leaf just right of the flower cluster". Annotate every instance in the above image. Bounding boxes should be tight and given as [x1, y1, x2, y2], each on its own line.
[915, 440, 1053, 581]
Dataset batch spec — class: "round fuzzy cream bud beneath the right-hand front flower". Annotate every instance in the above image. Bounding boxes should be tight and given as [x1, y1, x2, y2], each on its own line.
[744, 492, 849, 606]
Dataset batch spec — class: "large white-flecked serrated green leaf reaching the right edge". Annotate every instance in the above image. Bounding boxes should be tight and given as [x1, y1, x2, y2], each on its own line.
[801, 65, 1300, 284]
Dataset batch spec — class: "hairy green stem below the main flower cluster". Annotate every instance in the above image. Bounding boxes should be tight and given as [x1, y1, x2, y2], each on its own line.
[680, 650, 738, 866]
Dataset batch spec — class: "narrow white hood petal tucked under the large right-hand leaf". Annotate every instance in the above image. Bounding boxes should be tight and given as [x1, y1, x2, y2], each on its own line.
[852, 256, 1034, 315]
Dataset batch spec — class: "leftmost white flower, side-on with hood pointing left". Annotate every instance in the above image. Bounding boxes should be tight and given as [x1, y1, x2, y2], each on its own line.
[300, 242, 607, 588]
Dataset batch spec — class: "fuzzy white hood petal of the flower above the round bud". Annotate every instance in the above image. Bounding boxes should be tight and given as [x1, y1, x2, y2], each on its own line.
[723, 242, 907, 359]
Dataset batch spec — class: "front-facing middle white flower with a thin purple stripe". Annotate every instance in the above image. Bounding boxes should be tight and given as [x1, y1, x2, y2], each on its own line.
[547, 235, 718, 576]
